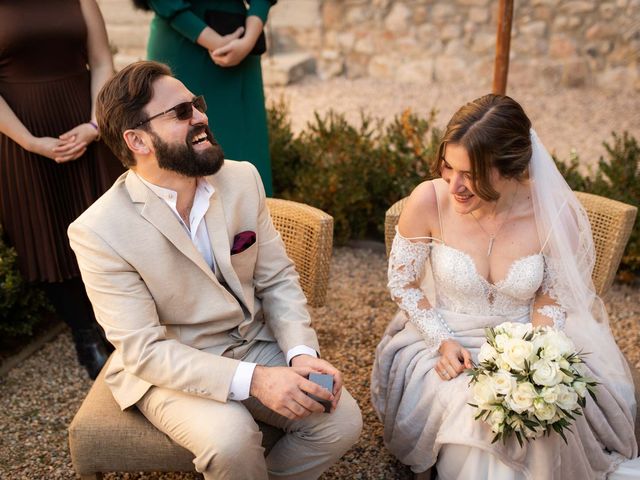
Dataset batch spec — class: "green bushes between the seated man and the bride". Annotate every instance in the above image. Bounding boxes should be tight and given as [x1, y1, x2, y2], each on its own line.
[267, 100, 440, 244]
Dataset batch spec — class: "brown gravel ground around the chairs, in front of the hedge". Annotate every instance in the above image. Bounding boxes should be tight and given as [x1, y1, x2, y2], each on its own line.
[0, 245, 640, 480]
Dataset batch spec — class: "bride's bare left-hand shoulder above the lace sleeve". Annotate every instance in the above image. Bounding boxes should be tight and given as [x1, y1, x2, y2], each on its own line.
[398, 179, 442, 236]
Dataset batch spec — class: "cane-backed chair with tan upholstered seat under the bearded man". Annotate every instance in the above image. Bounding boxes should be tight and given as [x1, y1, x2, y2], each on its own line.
[69, 199, 333, 479]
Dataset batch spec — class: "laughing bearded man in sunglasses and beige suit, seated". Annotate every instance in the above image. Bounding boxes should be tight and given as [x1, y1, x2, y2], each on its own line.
[69, 62, 362, 479]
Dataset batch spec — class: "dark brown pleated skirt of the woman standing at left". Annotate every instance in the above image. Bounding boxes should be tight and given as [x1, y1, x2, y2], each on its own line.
[0, 70, 124, 282]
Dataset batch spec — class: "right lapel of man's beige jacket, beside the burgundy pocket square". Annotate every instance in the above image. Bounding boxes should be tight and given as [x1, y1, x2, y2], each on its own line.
[204, 189, 247, 305]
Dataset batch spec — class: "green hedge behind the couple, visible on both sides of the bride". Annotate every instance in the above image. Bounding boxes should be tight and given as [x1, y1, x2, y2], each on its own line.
[267, 100, 640, 273]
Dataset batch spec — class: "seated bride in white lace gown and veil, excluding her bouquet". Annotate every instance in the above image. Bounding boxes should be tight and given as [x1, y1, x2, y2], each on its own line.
[371, 95, 637, 480]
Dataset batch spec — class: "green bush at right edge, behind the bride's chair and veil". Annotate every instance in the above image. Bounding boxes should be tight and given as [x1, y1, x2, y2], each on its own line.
[554, 132, 640, 275]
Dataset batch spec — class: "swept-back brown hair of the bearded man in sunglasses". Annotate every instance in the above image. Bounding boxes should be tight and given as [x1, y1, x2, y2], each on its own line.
[96, 61, 172, 168]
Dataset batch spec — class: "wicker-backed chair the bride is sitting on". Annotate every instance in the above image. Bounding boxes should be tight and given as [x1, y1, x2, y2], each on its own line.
[384, 192, 640, 446]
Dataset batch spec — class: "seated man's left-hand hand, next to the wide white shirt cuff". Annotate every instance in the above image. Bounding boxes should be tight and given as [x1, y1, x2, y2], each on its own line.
[249, 366, 334, 420]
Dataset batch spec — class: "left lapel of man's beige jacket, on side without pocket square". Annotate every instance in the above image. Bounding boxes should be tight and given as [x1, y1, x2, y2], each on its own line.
[125, 171, 218, 283]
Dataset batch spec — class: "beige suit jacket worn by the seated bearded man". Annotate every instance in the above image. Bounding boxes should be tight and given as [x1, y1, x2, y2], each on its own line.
[68, 160, 319, 409]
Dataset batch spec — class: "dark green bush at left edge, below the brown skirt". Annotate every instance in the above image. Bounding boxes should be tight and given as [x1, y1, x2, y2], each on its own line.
[0, 227, 51, 338]
